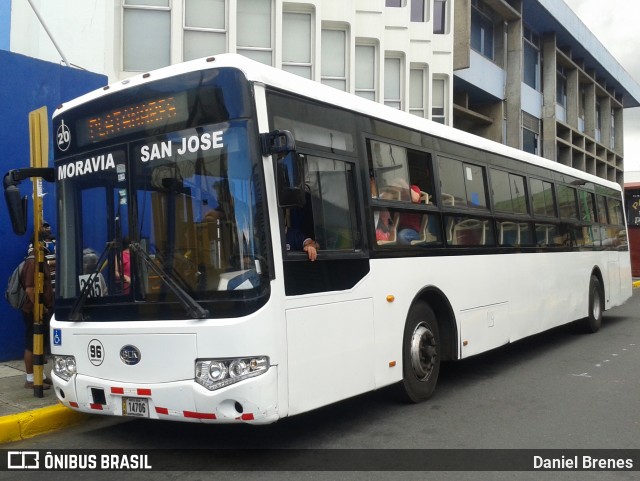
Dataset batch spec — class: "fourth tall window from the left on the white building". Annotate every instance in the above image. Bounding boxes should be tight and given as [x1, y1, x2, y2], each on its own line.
[282, 12, 312, 79]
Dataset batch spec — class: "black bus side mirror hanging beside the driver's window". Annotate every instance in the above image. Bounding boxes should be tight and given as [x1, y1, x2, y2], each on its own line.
[260, 130, 304, 207]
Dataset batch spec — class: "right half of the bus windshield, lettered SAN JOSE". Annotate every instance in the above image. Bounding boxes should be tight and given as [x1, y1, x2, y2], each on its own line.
[133, 123, 263, 294]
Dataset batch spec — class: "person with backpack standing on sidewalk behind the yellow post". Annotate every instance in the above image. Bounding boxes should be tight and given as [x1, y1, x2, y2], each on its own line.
[20, 244, 53, 389]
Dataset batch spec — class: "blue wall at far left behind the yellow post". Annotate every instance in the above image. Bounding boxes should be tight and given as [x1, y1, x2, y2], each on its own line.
[0, 51, 107, 361]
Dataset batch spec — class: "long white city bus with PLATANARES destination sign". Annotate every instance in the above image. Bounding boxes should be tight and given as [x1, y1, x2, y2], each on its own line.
[6, 55, 632, 424]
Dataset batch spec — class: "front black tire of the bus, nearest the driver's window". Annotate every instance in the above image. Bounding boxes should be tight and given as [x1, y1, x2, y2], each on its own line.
[402, 302, 441, 403]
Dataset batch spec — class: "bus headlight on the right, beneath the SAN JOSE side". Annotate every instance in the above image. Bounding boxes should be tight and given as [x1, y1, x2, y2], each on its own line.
[195, 356, 269, 391]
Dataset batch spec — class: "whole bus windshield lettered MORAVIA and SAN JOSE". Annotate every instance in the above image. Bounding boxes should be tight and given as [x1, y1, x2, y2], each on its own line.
[56, 120, 266, 315]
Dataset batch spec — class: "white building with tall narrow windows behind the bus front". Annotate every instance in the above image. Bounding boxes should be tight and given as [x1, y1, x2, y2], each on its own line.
[5, 0, 454, 123]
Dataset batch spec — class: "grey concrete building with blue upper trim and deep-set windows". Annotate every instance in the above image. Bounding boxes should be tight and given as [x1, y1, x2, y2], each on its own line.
[453, 0, 640, 184]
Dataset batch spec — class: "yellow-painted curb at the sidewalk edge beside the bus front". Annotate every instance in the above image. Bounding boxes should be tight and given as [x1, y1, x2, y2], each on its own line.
[0, 404, 88, 444]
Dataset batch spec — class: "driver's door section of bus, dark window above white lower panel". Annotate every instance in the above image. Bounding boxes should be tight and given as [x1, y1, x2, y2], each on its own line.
[282, 154, 374, 414]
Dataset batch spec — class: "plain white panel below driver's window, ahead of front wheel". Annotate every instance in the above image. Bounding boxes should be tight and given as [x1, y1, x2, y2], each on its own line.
[286, 298, 375, 415]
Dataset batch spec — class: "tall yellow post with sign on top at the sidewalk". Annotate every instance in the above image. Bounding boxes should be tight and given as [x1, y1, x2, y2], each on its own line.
[29, 107, 49, 397]
